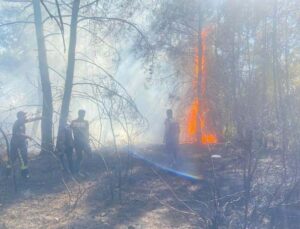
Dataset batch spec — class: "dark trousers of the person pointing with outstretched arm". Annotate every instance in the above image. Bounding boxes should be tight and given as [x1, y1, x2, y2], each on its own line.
[9, 141, 28, 170]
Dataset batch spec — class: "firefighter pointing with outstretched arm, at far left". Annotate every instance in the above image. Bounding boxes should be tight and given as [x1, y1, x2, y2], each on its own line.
[8, 111, 42, 178]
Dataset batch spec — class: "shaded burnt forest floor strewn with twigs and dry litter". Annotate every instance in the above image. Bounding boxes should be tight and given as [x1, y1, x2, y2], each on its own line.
[0, 146, 241, 229]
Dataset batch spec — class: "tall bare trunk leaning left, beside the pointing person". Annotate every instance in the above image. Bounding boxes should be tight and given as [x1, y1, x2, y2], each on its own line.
[32, 0, 53, 153]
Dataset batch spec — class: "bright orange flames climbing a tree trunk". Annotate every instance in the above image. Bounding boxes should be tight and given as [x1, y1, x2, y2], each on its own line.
[184, 29, 218, 144]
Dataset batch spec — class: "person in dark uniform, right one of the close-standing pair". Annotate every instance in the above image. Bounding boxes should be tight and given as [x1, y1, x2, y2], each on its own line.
[71, 110, 91, 173]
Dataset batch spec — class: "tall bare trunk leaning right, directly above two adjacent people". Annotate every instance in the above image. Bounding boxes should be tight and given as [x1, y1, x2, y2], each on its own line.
[58, 0, 80, 147]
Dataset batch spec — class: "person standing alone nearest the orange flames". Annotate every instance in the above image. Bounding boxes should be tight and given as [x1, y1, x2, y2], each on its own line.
[164, 109, 180, 164]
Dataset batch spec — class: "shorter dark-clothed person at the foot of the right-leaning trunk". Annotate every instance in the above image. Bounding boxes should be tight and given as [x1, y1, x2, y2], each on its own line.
[56, 124, 75, 173]
